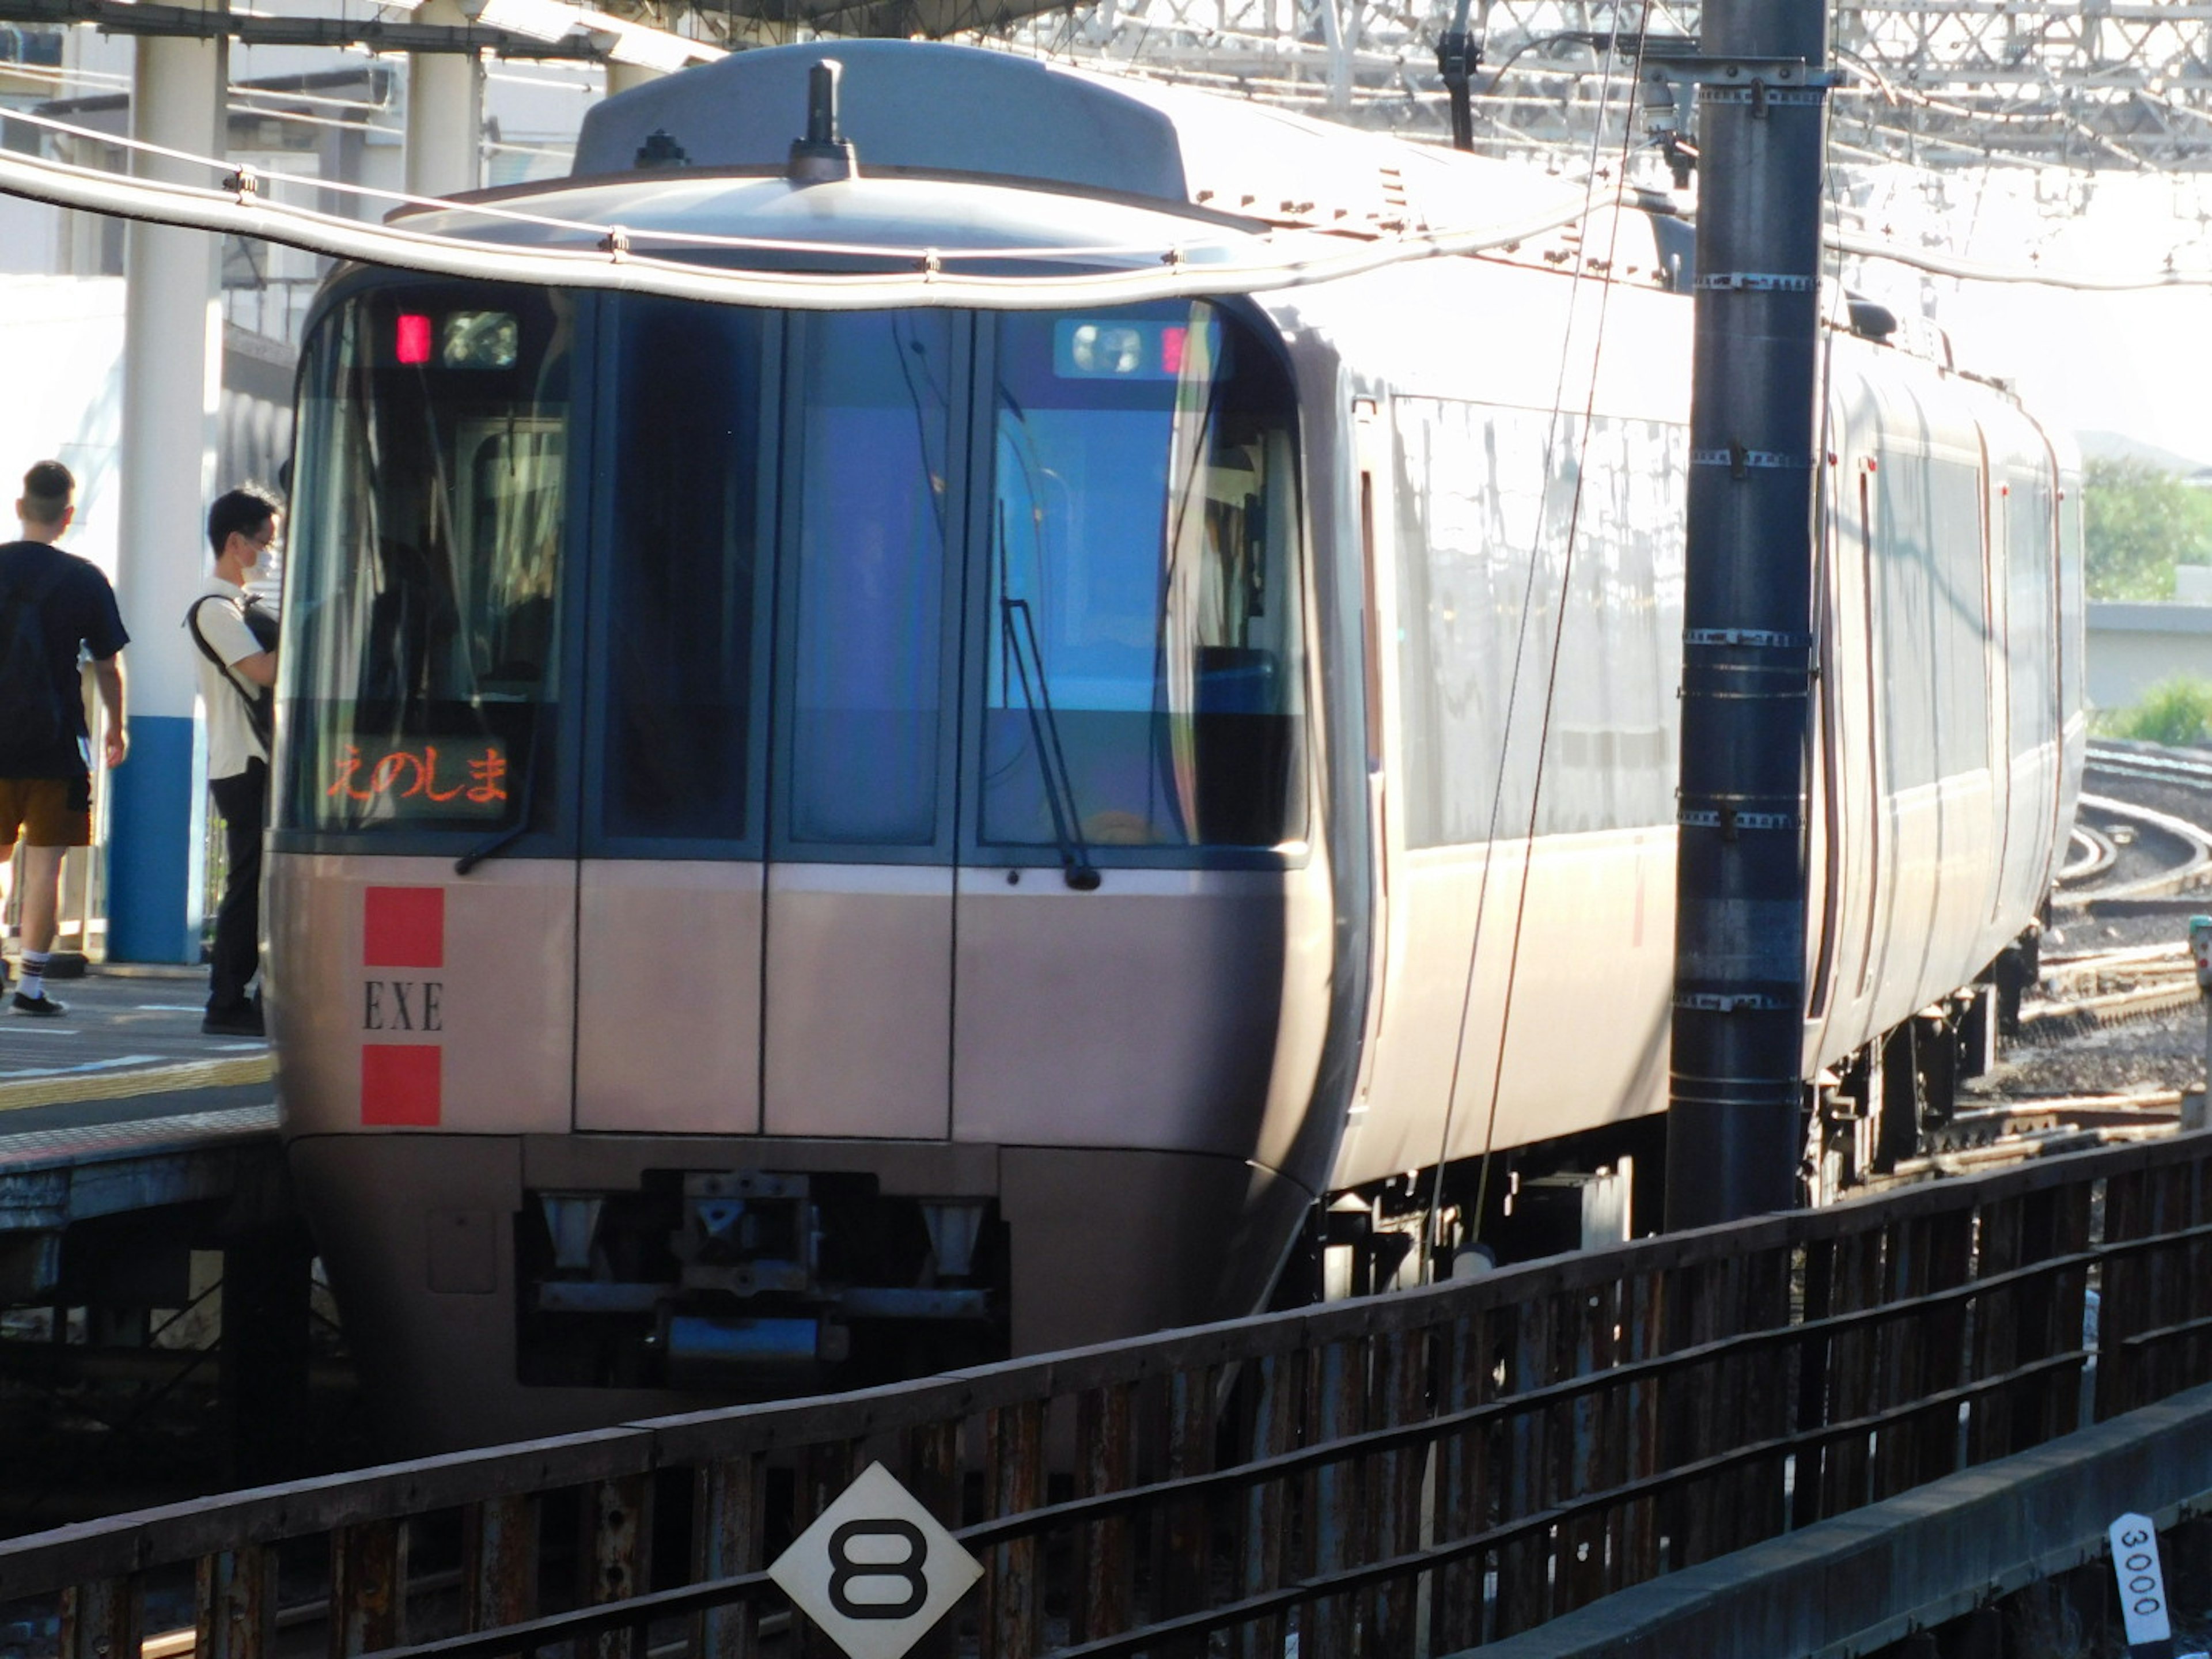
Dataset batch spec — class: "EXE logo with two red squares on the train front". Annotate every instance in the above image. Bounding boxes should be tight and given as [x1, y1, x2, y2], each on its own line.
[361, 887, 445, 1128]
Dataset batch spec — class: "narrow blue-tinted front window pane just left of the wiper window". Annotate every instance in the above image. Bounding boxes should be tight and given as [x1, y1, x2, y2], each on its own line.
[787, 312, 953, 847]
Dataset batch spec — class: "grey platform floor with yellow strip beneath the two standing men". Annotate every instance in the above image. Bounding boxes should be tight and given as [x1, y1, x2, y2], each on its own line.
[0, 967, 274, 1139]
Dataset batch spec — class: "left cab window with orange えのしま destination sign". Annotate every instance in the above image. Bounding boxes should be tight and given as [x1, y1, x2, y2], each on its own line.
[279, 285, 573, 832]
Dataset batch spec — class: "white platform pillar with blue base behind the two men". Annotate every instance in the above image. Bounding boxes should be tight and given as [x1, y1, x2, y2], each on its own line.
[108, 22, 230, 962]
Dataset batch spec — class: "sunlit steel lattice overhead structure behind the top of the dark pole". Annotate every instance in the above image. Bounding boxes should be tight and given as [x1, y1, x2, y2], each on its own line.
[929, 0, 2212, 173]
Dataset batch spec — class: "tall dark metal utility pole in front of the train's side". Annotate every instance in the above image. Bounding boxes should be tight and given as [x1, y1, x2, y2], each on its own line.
[1666, 0, 1827, 1228]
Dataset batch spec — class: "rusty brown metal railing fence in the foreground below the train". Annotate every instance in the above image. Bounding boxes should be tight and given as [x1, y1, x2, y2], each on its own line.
[0, 1135, 2212, 1659]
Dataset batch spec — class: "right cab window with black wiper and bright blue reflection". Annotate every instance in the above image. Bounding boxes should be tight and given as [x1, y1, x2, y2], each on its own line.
[980, 305, 1305, 847]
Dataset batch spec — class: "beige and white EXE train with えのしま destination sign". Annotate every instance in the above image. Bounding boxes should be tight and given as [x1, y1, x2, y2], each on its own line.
[272, 42, 2081, 1446]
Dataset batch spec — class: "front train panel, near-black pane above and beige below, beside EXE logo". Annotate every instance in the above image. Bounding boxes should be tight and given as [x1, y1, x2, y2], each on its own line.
[575, 298, 779, 1135]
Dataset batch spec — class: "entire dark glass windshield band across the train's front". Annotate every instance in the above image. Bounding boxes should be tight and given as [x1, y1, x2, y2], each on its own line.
[279, 283, 1307, 863]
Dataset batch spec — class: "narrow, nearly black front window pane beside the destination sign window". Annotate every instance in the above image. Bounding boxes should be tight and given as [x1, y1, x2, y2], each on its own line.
[601, 298, 767, 840]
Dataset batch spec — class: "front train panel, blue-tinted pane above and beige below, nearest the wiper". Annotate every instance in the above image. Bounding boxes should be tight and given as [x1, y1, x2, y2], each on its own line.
[761, 310, 974, 1139]
